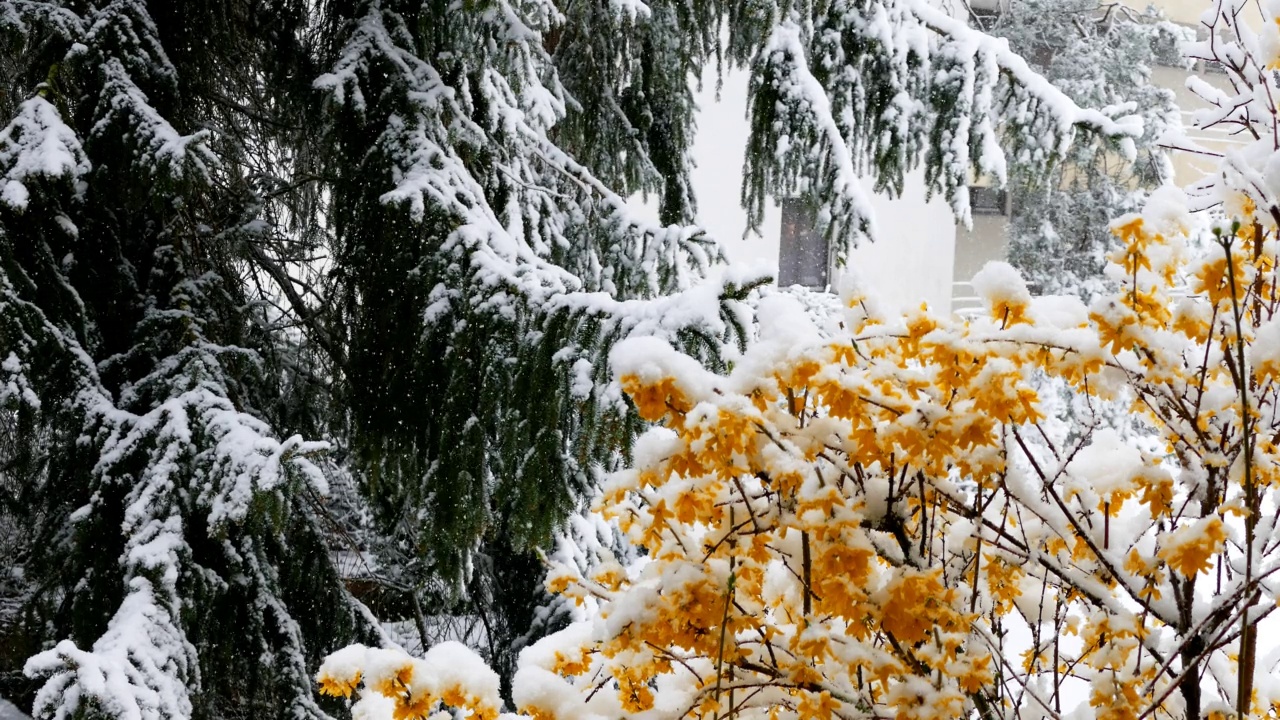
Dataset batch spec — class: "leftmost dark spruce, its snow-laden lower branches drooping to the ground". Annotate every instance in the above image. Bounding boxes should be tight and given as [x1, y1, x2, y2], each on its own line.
[0, 0, 376, 719]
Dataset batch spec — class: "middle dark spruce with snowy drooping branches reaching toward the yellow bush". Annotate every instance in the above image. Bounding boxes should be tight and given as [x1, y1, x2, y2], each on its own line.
[316, 1, 756, 681]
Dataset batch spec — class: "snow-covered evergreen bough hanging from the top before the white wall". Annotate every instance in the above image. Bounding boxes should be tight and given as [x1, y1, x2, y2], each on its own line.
[742, 0, 1140, 259]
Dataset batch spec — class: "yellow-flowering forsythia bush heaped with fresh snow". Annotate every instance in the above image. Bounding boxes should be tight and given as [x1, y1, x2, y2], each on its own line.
[320, 180, 1280, 720]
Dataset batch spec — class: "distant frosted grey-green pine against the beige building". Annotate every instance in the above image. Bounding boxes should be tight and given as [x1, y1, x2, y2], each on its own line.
[977, 0, 1194, 300]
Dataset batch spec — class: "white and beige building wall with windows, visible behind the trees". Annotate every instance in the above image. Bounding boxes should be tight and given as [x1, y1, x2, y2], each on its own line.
[650, 0, 1218, 313]
